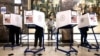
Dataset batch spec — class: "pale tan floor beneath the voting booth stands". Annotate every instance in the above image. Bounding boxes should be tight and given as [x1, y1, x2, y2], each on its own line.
[0, 46, 100, 56]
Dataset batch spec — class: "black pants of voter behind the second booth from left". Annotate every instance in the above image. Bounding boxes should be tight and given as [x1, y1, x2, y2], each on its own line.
[34, 26, 43, 47]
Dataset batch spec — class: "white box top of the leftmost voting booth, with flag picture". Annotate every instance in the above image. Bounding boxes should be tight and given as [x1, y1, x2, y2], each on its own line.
[3, 14, 22, 28]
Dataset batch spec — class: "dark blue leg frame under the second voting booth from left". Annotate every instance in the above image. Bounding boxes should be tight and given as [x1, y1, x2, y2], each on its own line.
[24, 28, 45, 56]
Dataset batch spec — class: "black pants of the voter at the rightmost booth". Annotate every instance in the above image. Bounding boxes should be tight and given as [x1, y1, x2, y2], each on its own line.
[80, 27, 88, 45]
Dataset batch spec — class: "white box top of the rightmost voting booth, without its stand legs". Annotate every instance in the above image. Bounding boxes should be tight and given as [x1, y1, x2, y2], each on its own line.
[78, 13, 98, 28]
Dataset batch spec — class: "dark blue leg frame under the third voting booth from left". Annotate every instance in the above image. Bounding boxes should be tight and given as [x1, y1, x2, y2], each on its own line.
[55, 28, 78, 56]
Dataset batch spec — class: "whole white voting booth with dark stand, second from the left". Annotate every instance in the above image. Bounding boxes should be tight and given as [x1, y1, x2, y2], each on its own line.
[24, 10, 45, 55]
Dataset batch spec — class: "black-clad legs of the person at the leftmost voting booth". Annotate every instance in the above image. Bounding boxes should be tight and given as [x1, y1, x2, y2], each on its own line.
[9, 27, 20, 45]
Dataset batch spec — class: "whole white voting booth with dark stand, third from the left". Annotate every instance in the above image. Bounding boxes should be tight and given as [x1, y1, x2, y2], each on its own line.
[56, 10, 78, 54]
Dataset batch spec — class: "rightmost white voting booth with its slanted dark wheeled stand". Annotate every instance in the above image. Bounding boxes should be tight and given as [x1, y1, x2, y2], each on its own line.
[78, 13, 99, 51]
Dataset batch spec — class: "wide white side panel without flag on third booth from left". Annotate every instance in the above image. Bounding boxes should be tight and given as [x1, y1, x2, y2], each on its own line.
[56, 11, 71, 28]
